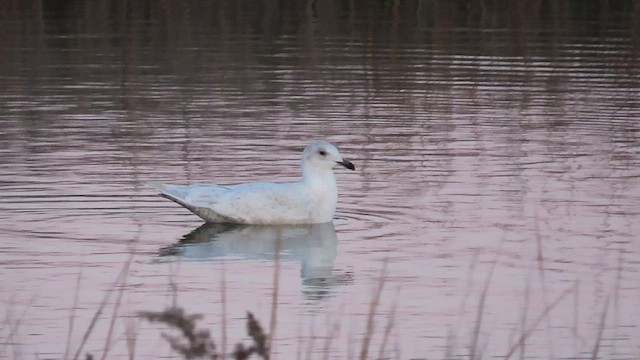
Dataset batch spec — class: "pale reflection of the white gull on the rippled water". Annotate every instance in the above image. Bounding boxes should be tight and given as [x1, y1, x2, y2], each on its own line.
[160, 222, 352, 299]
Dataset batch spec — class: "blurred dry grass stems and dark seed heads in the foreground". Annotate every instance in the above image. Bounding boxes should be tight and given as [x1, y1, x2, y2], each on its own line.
[0, 243, 623, 360]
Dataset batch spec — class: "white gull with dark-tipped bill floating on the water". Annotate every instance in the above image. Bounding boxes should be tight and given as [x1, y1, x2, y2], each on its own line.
[146, 140, 355, 225]
